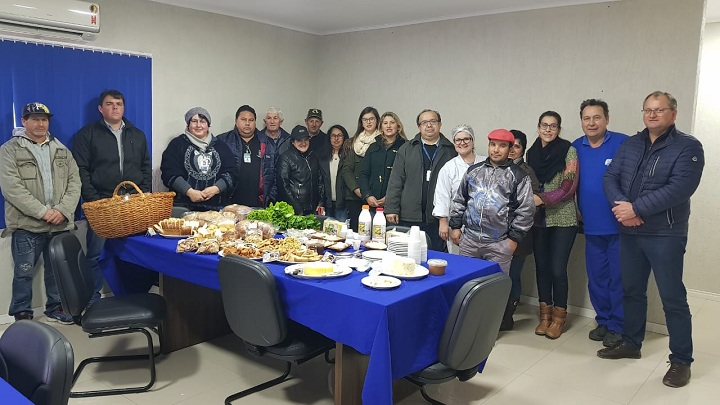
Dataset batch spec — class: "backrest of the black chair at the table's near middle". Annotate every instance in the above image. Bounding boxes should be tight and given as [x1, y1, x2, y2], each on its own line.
[218, 255, 288, 346]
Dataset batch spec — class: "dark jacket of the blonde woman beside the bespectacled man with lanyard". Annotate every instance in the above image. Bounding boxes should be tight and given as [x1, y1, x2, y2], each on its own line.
[358, 135, 405, 200]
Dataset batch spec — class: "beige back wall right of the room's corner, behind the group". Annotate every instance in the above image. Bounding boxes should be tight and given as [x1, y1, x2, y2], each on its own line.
[318, 0, 708, 323]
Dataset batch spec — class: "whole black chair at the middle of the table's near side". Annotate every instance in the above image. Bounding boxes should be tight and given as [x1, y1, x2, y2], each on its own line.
[218, 255, 336, 404]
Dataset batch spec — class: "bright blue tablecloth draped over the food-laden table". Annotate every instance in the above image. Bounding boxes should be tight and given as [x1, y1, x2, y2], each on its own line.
[101, 236, 500, 405]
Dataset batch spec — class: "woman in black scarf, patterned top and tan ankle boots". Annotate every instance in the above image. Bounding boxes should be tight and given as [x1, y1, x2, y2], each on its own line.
[527, 111, 578, 339]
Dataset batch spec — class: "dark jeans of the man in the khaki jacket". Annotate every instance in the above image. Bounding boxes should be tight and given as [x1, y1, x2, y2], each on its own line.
[8, 229, 62, 316]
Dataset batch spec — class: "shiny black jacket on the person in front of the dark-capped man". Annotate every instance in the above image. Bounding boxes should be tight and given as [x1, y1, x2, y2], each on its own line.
[276, 145, 325, 215]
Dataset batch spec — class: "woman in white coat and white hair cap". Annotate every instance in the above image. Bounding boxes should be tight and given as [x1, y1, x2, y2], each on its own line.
[433, 124, 487, 254]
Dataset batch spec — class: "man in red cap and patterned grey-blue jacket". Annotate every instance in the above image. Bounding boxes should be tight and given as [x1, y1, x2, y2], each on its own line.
[449, 129, 535, 274]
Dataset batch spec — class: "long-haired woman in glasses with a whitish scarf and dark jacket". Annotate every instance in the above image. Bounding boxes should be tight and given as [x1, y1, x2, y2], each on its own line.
[342, 107, 380, 231]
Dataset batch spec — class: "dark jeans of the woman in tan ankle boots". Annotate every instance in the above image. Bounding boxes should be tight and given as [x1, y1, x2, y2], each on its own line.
[533, 226, 577, 308]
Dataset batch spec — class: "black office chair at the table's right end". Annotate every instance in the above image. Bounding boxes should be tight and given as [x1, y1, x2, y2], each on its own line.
[405, 273, 511, 405]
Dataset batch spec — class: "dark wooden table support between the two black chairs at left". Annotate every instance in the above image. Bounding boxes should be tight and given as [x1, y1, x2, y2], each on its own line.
[160, 274, 232, 353]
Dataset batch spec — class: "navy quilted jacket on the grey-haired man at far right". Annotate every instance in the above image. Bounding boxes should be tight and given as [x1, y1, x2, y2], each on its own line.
[603, 125, 705, 236]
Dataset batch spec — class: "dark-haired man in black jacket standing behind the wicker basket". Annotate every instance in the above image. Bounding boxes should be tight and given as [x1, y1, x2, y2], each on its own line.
[72, 90, 152, 303]
